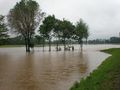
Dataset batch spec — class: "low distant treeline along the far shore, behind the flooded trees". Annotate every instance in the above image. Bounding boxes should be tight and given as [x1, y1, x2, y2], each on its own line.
[0, 36, 120, 45]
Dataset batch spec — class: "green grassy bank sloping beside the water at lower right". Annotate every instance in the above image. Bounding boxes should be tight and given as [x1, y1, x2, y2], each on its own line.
[70, 48, 120, 90]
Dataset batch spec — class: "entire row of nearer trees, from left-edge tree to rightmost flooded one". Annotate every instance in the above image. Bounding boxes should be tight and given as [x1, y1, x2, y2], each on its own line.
[0, 0, 89, 52]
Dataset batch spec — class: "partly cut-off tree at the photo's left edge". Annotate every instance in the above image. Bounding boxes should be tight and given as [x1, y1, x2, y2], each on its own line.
[0, 15, 9, 44]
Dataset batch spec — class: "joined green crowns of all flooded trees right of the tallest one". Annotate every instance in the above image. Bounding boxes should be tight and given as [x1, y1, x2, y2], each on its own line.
[39, 15, 89, 48]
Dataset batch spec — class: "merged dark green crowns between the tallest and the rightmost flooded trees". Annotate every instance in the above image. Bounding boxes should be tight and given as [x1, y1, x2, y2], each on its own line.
[39, 15, 74, 39]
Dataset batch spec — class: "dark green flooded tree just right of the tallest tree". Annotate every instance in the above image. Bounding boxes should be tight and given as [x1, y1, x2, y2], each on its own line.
[39, 15, 55, 51]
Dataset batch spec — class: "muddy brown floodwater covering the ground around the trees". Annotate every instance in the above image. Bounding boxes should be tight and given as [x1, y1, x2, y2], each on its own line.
[0, 45, 120, 90]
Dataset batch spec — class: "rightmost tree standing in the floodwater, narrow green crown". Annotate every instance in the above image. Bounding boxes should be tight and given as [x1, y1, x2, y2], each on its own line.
[75, 19, 89, 51]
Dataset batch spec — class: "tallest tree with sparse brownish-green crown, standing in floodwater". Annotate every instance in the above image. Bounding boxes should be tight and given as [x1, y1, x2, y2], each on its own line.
[8, 0, 44, 52]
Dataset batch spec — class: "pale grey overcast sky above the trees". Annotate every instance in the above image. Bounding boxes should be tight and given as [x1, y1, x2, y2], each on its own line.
[0, 0, 120, 39]
